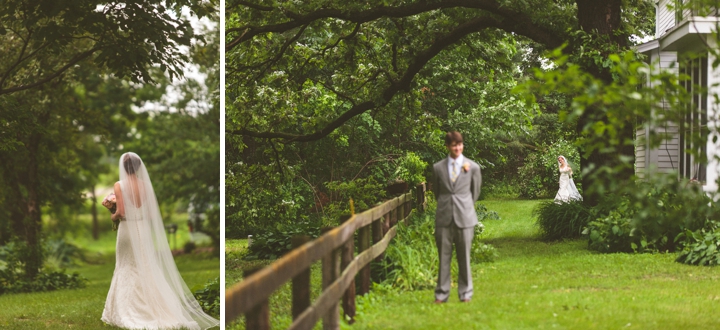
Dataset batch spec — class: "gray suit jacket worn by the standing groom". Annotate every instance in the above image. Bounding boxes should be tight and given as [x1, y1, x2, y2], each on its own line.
[432, 158, 482, 228]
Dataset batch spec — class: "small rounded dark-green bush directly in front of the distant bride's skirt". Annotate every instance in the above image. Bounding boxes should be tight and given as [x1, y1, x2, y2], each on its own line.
[533, 201, 591, 241]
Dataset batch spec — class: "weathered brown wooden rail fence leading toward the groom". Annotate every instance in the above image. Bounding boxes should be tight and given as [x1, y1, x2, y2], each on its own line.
[225, 183, 427, 330]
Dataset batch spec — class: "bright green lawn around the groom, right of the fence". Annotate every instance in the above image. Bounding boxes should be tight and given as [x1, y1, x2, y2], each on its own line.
[347, 201, 720, 329]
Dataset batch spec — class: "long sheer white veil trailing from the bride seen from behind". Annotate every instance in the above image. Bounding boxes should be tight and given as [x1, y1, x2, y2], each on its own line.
[120, 152, 220, 329]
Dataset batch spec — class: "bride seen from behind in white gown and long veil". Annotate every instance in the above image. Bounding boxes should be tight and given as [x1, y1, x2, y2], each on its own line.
[102, 153, 220, 329]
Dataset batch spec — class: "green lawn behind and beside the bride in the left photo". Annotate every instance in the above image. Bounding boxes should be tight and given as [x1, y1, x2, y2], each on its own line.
[0, 213, 220, 329]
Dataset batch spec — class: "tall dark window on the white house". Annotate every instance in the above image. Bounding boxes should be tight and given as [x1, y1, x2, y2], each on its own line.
[679, 54, 708, 183]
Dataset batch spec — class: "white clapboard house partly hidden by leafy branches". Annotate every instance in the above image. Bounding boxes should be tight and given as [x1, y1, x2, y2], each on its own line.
[635, 0, 720, 192]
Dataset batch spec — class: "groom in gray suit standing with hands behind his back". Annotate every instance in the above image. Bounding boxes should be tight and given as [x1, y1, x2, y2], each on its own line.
[432, 132, 482, 304]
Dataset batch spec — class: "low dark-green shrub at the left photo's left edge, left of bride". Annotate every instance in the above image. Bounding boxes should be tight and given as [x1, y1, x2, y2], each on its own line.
[0, 242, 87, 295]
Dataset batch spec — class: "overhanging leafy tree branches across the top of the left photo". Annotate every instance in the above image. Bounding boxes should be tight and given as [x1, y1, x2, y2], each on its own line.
[0, 0, 217, 95]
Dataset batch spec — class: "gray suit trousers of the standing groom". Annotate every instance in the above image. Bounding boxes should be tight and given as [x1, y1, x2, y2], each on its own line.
[435, 221, 475, 301]
